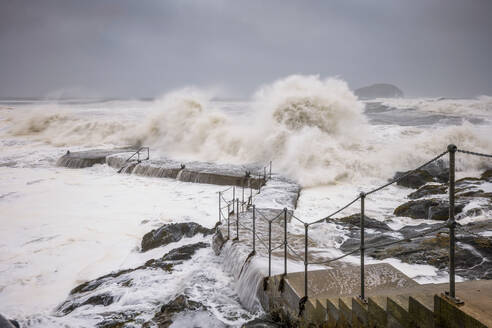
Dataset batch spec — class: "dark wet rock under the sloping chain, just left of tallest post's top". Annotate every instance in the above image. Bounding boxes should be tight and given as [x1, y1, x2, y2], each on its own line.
[394, 161, 449, 189]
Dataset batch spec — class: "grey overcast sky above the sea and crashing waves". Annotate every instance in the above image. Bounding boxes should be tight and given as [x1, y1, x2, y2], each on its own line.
[0, 0, 492, 97]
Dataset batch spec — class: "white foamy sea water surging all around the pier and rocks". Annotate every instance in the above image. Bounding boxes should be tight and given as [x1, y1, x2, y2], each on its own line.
[0, 76, 492, 327]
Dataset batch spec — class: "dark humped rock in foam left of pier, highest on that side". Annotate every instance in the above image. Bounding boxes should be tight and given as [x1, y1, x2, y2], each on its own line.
[142, 222, 215, 252]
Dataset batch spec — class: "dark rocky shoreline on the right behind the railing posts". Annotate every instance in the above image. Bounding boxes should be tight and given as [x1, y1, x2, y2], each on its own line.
[333, 165, 492, 279]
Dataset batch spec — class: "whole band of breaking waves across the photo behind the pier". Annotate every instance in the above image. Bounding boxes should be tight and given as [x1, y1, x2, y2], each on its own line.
[3, 75, 492, 186]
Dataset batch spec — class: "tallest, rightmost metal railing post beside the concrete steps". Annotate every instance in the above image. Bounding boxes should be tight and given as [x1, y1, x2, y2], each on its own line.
[448, 144, 457, 299]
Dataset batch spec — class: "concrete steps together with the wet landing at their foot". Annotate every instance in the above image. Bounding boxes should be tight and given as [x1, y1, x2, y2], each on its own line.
[259, 263, 492, 328]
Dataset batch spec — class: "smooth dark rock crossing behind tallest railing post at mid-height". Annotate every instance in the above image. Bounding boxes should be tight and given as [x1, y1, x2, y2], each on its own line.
[393, 198, 465, 221]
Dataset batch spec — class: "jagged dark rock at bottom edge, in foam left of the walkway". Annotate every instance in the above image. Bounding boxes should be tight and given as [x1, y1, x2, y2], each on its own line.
[148, 295, 207, 328]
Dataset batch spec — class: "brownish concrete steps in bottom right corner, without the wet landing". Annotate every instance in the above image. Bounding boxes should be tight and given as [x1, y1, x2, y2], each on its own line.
[302, 280, 492, 328]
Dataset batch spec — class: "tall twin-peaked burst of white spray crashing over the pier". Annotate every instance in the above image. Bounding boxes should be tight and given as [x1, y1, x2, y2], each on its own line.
[129, 75, 369, 185]
